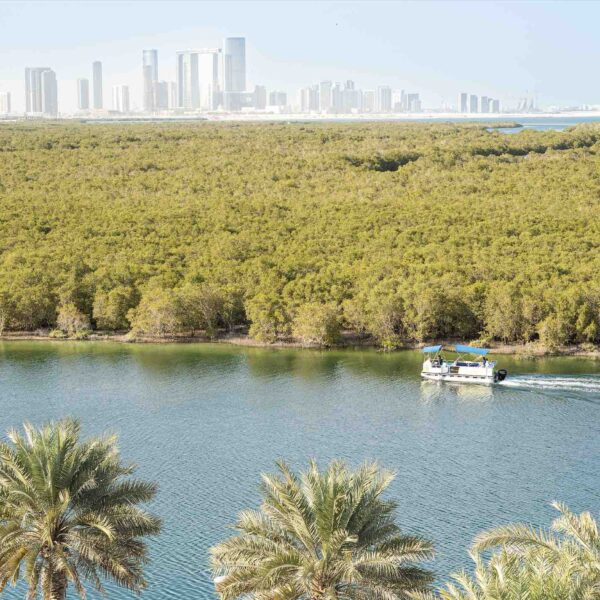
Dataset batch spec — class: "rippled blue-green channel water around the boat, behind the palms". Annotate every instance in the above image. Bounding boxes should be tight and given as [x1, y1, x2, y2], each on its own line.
[0, 342, 600, 599]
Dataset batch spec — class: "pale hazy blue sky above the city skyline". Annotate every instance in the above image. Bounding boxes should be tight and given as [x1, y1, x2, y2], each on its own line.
[0, 0, 600, 111]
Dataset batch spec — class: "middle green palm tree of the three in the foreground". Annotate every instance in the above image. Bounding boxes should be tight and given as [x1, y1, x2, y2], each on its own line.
[211, 461, 433, 600]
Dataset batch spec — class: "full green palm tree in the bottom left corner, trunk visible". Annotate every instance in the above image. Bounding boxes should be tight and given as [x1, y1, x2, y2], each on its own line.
[0, 419, 160, 600]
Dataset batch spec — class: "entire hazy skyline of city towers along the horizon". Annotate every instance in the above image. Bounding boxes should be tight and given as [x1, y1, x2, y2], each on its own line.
[0, 37, 534, 117]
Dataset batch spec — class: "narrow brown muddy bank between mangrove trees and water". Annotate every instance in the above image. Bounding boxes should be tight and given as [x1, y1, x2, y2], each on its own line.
[0, 331, 600, 360]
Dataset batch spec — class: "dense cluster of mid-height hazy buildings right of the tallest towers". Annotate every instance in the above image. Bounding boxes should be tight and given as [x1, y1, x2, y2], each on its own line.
[298, 80, 422, 114]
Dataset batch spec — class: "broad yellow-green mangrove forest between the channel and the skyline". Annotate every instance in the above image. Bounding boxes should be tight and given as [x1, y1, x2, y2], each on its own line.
[0, 123, 600, 349]
